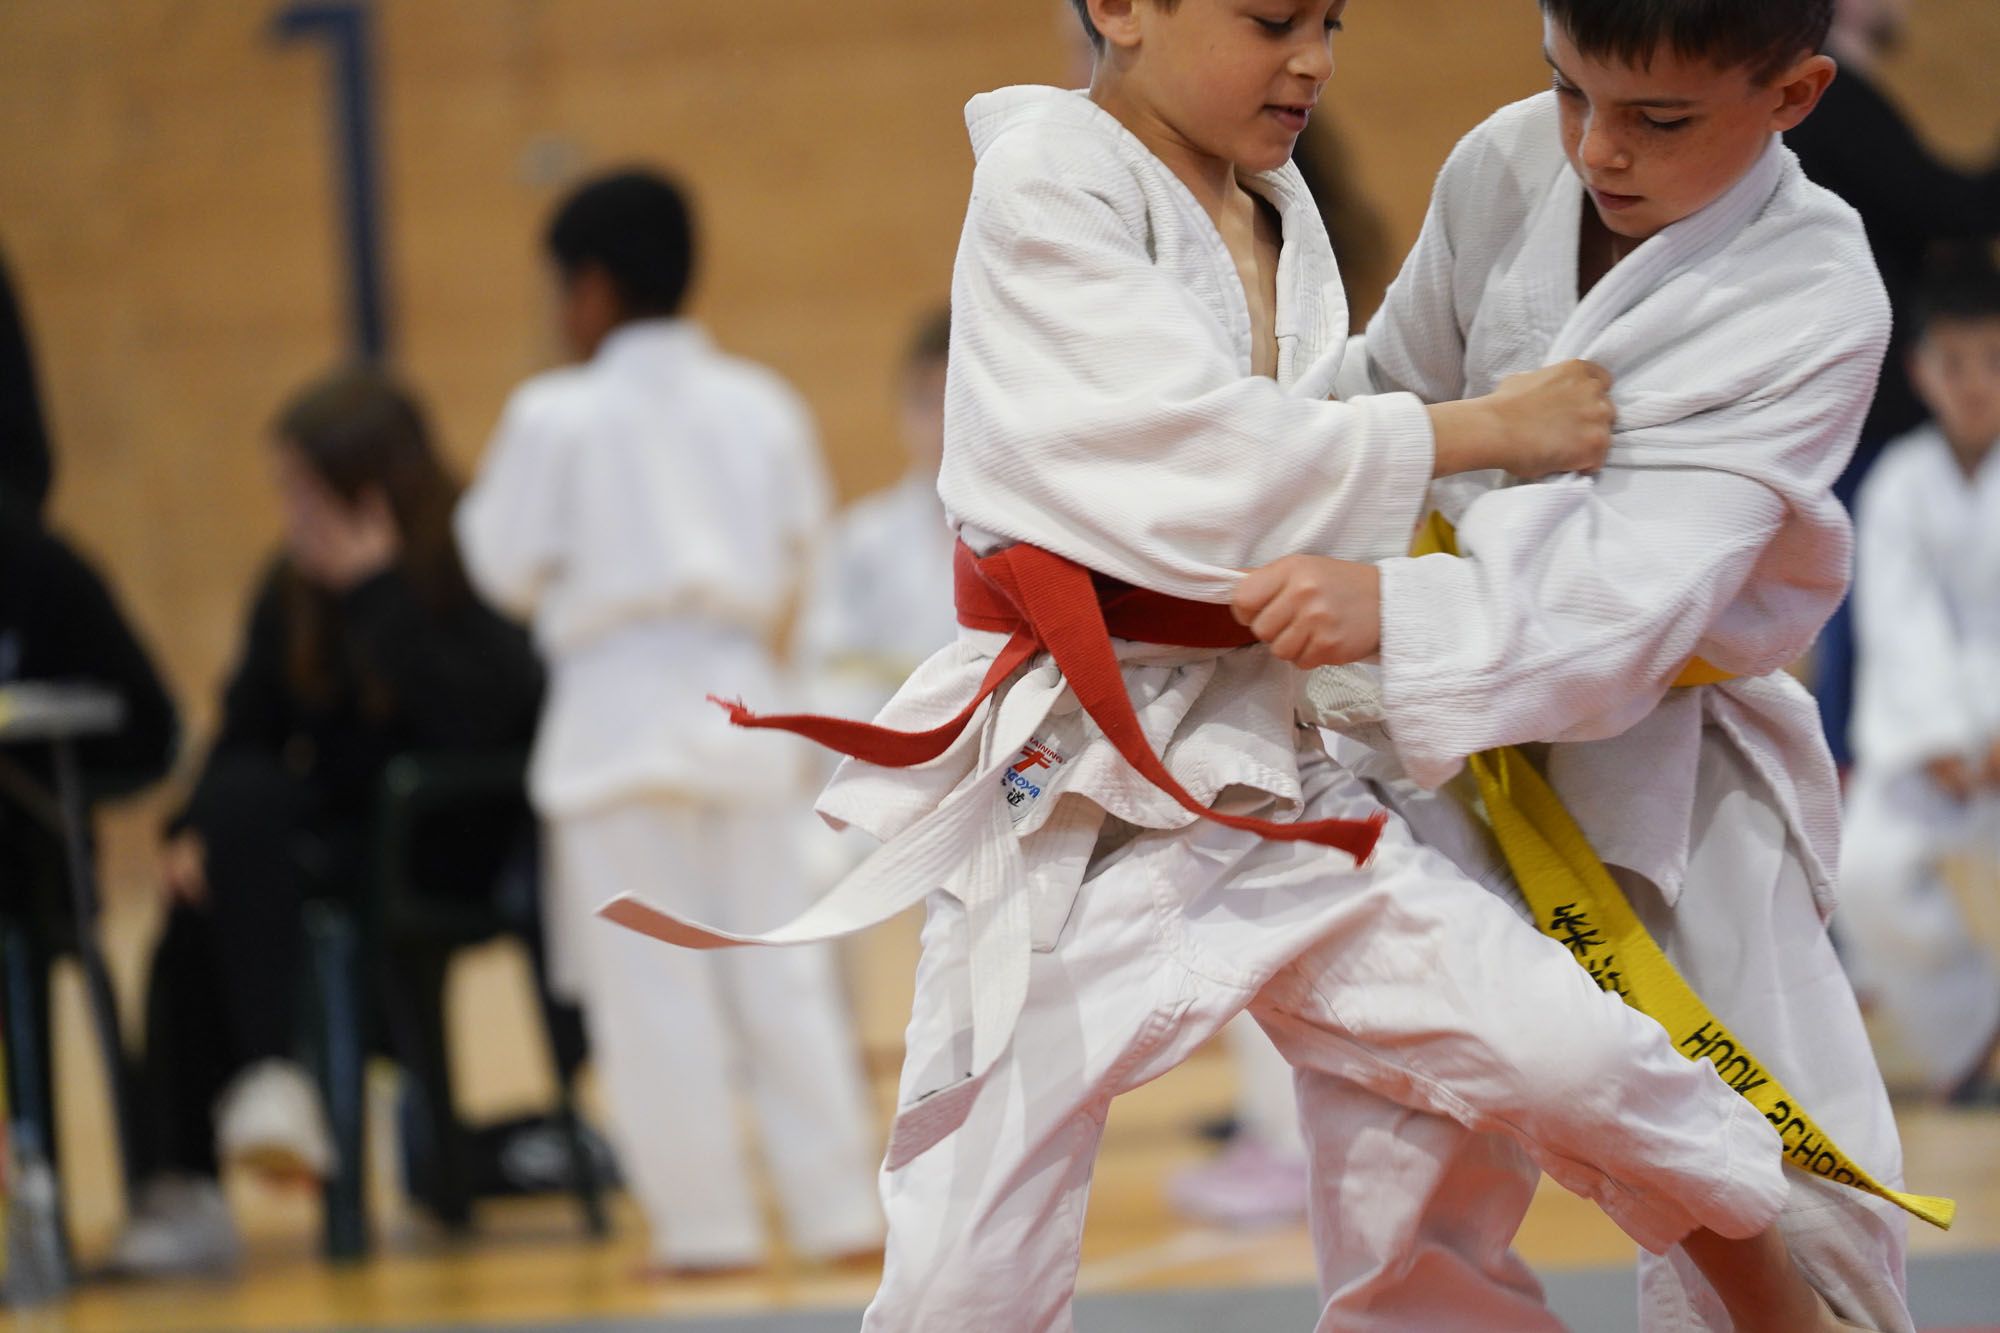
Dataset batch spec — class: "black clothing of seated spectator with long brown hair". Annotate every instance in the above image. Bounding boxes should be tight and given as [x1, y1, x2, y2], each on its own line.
[142, 566, 542, 1177]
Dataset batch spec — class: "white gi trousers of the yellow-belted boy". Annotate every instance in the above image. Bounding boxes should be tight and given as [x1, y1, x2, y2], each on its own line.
[1300, 731, 1912, 1333]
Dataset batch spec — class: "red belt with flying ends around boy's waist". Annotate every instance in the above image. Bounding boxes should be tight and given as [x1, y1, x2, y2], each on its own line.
[716, 544, 1386, 863]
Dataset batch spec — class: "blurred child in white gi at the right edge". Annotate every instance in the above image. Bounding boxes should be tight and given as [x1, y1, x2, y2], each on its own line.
[1840, 264, 2000, 1099]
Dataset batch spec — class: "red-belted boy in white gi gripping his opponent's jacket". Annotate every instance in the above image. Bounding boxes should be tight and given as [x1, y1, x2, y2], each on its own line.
[606, 0, 1864, 1333]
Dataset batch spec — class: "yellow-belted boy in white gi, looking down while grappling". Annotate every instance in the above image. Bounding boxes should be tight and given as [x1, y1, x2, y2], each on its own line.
[1238, 0, 1910, 1329]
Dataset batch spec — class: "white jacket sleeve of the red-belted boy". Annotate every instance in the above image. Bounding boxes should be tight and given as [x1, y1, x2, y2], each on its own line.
[940, 154, 1434, 602]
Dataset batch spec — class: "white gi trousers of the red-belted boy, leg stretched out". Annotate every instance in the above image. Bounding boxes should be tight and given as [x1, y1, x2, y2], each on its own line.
[864, 753, 1786, 1333]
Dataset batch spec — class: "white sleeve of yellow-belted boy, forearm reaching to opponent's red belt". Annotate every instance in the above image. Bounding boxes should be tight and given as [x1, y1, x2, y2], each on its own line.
[1382, 468, 1792, 787]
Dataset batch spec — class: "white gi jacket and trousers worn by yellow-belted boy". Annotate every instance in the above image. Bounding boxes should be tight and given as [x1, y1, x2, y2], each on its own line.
[1312, 94, 1910, 1333]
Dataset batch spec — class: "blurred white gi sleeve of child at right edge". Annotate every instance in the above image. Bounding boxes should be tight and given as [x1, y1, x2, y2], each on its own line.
[1854, 454, 1984, 771]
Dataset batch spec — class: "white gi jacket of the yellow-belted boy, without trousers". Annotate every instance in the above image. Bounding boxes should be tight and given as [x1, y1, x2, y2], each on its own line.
[1342, 92, 1888, 915]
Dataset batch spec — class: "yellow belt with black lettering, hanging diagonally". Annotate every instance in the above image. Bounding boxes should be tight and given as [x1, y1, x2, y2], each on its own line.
[1414, 512, 1958, 1229]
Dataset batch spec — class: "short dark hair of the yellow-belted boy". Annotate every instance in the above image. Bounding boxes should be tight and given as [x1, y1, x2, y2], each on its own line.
[1540, 0, 1834, 82]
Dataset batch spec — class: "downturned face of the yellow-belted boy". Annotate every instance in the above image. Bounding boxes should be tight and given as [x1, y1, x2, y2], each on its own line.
[1544, 20, 1810, 240]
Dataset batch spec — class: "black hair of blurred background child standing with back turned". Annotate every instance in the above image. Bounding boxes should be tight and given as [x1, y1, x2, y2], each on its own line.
[546, 170, 694, 318]
